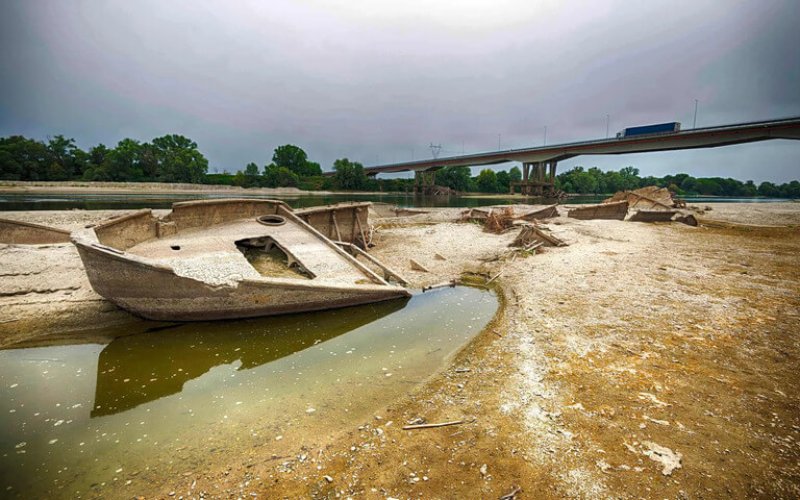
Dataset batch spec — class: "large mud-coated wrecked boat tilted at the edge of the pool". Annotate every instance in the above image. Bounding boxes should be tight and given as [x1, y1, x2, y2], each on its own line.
[72, 199, 410, 321]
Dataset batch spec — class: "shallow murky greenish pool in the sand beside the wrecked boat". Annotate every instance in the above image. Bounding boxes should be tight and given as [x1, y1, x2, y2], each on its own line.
[0, 287, 498, 497]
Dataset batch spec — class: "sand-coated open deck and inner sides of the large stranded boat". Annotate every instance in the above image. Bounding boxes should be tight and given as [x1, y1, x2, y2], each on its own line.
[87, 200, 396, 285]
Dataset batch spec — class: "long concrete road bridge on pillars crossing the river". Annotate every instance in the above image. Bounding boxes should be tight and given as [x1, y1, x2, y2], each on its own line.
[326, 117, 800, 195]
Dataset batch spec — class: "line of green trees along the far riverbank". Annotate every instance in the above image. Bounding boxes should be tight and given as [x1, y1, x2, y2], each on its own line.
[0, 134, 800, 198]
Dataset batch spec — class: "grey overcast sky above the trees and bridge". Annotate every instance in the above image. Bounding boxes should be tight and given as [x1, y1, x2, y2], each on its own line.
[0, 0, 800, 182]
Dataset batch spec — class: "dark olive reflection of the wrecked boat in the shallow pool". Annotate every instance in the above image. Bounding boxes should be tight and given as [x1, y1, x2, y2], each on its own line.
[91, 298, 409, 418]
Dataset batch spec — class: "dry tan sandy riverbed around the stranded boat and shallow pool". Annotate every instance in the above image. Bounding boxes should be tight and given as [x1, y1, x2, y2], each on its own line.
[0, 203, 800, 498]
